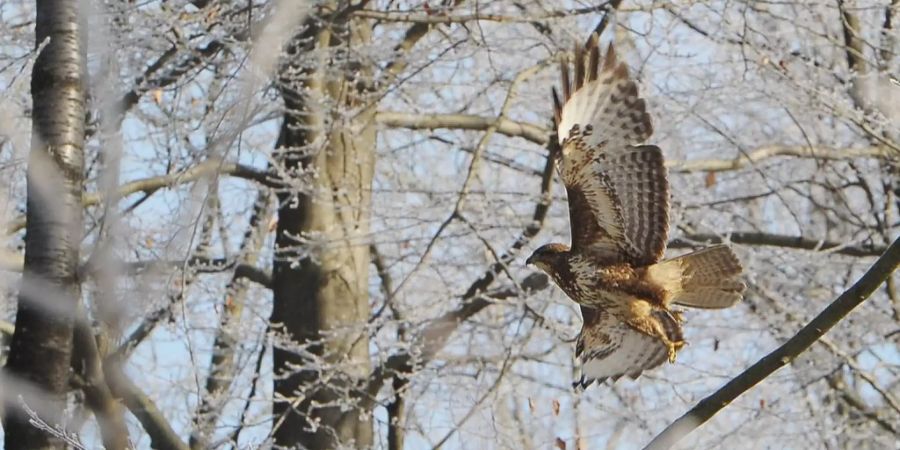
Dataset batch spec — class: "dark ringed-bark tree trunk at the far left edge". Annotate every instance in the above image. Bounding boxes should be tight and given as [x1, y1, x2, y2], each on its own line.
[4, 0, 86, 450]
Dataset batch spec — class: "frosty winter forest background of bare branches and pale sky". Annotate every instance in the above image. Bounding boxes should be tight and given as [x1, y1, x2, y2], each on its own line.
[0, 0, 900, 450]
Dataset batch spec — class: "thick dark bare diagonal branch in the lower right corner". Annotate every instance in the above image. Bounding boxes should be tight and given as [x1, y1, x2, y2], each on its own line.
[644, 238, 900, 450]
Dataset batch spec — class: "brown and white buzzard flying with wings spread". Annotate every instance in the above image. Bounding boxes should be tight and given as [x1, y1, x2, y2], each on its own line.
[526, 34, 745, 387]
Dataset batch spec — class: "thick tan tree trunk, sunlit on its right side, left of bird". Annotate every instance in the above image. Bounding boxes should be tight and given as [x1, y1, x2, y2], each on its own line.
[272, 15, 375, 448]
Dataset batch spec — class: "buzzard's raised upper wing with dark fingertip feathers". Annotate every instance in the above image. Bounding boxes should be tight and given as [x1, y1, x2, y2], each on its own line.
[553, 35, 669, 265]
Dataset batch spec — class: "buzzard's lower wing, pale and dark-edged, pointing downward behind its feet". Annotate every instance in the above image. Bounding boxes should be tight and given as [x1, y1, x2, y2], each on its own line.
[574, 306, 683, 389]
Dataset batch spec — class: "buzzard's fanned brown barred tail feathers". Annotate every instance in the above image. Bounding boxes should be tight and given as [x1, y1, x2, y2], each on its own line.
[648, 245, 746, 309]
